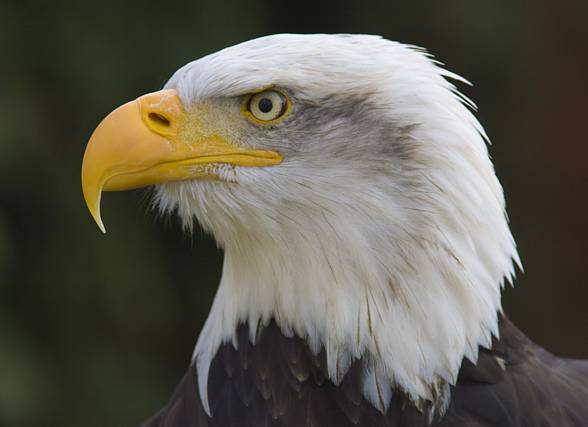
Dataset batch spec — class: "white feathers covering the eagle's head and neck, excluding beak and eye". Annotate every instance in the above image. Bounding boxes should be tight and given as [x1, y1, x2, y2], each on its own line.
[156, 35, 519, 418]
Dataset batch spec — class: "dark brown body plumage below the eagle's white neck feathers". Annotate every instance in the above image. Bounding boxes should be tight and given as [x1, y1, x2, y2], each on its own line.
[144, 317, 588, 427]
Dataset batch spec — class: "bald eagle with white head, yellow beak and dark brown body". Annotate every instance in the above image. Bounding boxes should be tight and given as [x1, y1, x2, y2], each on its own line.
[82, 34, 588, 427]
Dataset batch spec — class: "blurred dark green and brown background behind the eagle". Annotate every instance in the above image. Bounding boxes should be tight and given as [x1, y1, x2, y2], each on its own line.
[0, 0, 588, 427]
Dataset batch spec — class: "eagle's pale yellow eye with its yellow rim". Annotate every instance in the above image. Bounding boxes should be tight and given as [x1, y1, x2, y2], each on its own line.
[243, 89, 291, 124]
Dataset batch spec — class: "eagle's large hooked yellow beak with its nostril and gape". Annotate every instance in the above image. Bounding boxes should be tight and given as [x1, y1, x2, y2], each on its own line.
[82, 90, 282, 233]
